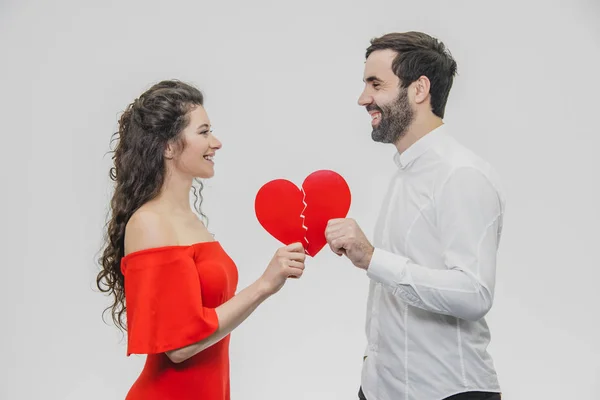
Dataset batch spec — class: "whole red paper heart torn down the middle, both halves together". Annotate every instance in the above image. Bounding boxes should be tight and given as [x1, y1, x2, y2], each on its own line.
[254, 170, 351, 257]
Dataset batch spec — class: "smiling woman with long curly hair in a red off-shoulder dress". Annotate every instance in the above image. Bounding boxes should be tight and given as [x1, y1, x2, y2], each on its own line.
[97, 81, 305, 400]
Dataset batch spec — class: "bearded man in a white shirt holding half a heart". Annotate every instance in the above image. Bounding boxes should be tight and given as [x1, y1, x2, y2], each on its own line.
[325, 32, 504, 400]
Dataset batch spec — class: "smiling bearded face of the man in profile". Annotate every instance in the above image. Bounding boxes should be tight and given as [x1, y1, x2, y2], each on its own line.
[358, 50, 414, 143]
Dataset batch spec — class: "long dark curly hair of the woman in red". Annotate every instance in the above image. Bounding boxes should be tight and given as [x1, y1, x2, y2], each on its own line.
[96, 80, 206, 330]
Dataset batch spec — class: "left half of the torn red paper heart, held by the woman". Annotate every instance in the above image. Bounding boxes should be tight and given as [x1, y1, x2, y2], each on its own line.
[254, 179, 308, 250]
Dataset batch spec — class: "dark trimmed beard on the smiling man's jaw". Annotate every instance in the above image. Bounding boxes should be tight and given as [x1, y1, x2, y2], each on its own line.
[367, 88, 414, 143]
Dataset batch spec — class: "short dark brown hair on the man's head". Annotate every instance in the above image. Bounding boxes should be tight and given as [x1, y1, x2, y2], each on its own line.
[365, 32, 457, 118]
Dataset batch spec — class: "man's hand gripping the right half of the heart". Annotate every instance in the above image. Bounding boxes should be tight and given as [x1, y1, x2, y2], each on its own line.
[325, 218, 375, 270]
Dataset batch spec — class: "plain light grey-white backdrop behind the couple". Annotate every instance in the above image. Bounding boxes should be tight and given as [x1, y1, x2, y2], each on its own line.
[0, 0, 600, 400]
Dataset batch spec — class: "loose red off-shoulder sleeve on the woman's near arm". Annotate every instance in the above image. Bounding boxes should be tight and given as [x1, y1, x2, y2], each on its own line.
[122, 248, 219, 356]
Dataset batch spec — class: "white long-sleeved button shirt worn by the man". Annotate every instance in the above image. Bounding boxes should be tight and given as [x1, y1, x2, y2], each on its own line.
[362, 125, 505, 400]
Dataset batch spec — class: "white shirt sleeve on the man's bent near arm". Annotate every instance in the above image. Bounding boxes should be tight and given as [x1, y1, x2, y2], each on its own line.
[367, 167, 503, 321]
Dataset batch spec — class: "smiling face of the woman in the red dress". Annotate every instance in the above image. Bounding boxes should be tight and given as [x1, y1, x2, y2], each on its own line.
[167, 106, 222, 178]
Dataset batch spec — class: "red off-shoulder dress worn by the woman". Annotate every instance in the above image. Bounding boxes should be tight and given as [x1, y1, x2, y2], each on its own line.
[121, 242, 238, 400]
